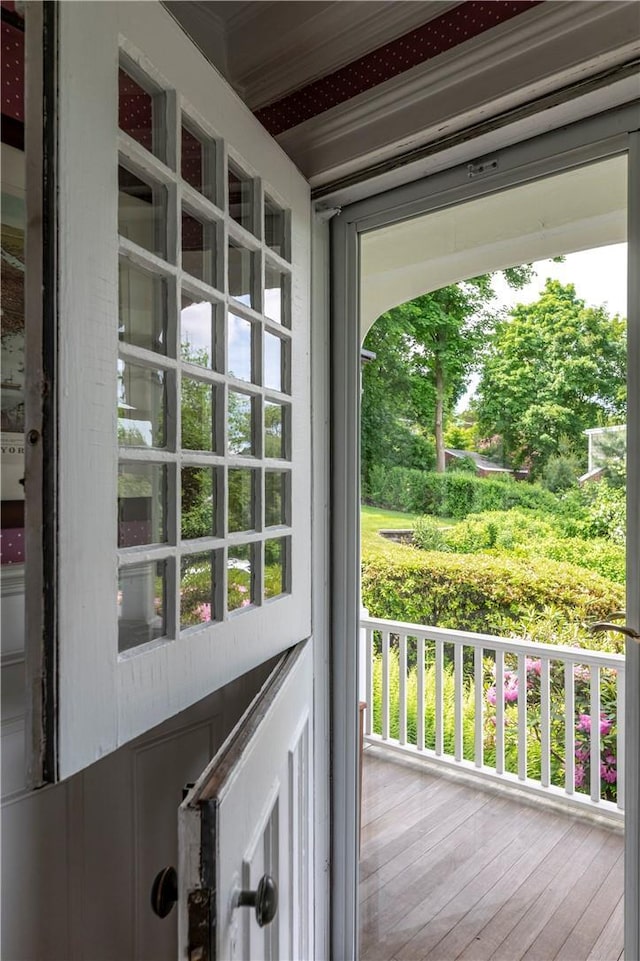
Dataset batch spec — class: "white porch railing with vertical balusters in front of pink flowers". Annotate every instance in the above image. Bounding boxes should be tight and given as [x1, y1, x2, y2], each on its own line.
[360, 617, 625, 819]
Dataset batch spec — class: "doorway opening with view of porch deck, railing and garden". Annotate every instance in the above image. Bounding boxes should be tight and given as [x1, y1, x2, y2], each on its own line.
[359, 156, 627, 961]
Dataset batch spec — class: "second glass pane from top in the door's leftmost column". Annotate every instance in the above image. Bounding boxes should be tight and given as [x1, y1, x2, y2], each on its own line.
[118, 166, 167, 257]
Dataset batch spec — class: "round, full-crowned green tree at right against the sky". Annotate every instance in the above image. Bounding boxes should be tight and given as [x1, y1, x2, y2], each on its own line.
[477, 280, 626, 473]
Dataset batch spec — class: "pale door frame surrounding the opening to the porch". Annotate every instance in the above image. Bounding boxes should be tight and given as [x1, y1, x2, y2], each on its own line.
[325, 102, 640, 961]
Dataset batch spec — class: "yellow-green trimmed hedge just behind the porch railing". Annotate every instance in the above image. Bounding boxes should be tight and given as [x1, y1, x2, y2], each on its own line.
[362, 547, 624, 634]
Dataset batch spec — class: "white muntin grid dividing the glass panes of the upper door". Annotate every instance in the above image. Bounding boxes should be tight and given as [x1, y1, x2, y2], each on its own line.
[114, 53, 294, 653]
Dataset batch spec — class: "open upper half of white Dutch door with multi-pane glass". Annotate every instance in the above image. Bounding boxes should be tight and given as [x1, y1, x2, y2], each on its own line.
[27, 2, 311, 782]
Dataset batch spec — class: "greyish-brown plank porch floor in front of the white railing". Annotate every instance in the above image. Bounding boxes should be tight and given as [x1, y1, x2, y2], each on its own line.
[360, 748, 623, 961]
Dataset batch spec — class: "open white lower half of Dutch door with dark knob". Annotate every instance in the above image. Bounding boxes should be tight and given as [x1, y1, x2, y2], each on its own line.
[178, 643, 313, 961]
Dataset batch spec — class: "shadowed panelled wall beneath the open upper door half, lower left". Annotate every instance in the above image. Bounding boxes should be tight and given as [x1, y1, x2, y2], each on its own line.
[0, 664, 272, 961]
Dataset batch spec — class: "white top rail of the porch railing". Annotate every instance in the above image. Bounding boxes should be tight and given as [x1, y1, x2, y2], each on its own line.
[360, 617, 625, 671]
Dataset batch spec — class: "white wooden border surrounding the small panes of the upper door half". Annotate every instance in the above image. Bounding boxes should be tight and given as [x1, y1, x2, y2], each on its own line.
[38, 2, 311, 777]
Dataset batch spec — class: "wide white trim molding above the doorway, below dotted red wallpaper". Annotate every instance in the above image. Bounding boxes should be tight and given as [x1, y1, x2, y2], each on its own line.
[277, 0, 640, 188]
